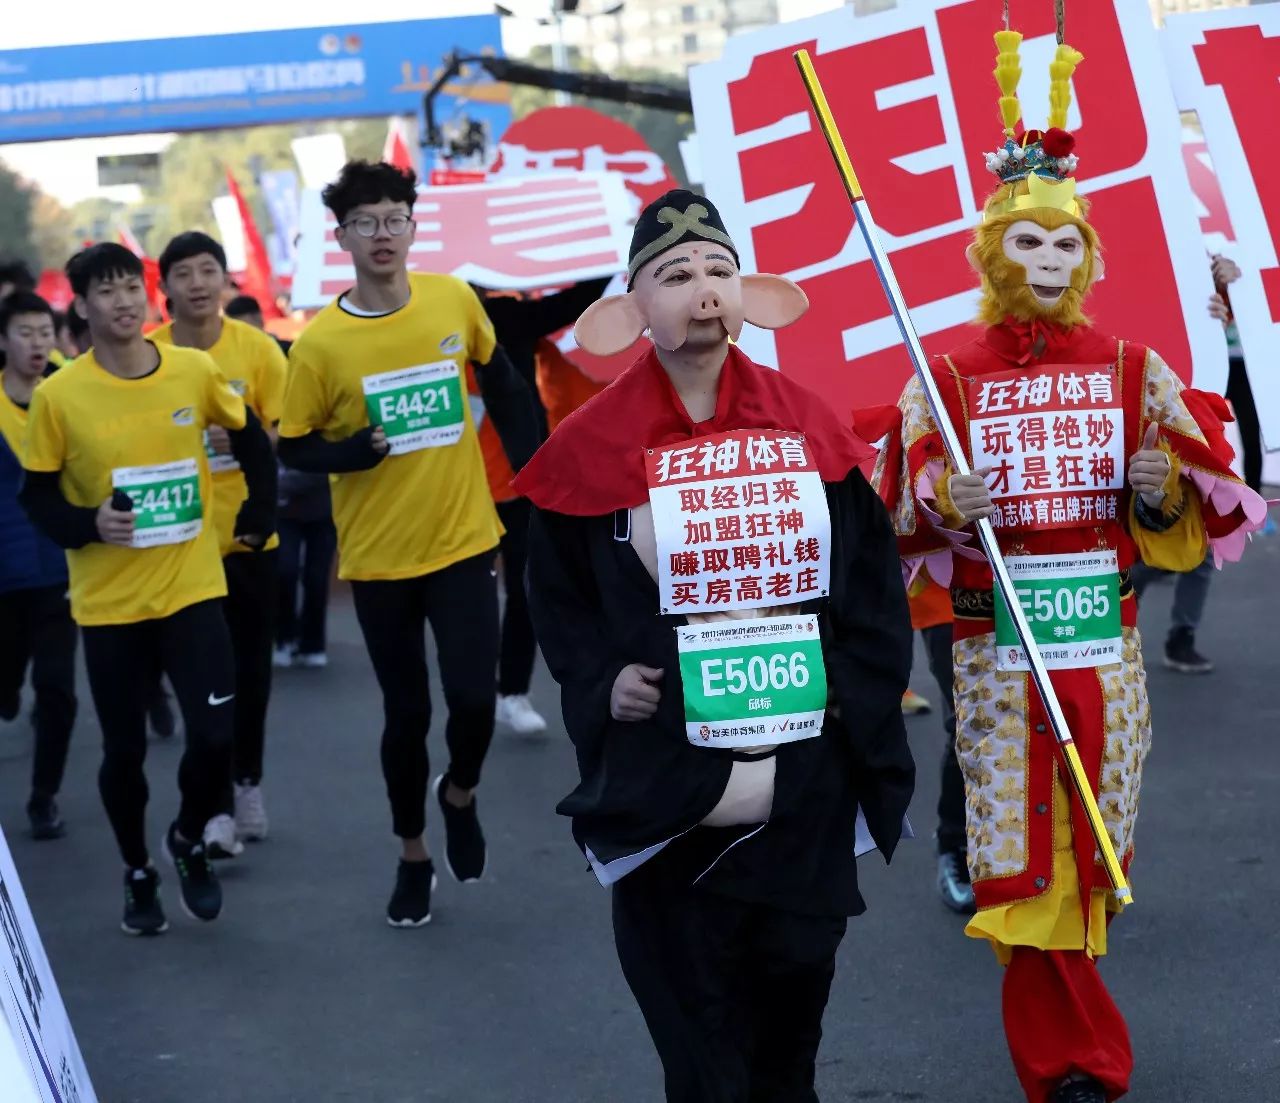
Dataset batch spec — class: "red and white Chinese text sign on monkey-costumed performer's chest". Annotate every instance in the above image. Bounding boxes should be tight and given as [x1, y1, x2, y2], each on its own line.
[968, 363, 1125, 530]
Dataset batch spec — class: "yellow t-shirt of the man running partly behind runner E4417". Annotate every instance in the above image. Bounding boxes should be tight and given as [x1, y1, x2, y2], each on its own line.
[147, 317, 288, 555]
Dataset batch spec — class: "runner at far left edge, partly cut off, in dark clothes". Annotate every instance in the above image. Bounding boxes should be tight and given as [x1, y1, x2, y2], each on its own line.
[0, 290, 76, 839]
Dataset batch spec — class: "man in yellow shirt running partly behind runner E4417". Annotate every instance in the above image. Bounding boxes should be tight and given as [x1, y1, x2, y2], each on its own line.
[151, 230, 285, 857]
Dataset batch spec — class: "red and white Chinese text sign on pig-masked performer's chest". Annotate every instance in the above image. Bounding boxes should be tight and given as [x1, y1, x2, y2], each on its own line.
[646, 429, 831, 614]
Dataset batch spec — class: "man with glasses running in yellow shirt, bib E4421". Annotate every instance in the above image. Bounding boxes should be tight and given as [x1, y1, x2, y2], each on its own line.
[279, 161, 538, 926]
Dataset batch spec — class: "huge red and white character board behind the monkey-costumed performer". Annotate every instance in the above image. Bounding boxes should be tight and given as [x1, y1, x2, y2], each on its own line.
[690, 0, 1226, 419]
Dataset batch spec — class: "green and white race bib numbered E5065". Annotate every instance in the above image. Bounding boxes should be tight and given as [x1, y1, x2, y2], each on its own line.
[996, 552, 1121, 671]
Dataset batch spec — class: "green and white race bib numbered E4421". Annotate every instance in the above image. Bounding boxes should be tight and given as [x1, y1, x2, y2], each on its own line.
[364, 360, 466, 456]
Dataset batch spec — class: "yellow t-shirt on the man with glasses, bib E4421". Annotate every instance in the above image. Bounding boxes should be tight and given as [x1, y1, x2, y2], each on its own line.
[280, 273, 503, 581]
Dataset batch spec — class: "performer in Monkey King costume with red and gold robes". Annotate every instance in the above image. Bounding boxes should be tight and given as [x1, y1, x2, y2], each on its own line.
[860, 31, 1266, 1103]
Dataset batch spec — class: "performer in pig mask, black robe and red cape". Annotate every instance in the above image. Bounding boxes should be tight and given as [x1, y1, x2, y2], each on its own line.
[513, 191, 915, 1103]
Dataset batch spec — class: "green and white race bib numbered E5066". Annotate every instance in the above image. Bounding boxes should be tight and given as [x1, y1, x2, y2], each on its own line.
[676, 615, 827, 747]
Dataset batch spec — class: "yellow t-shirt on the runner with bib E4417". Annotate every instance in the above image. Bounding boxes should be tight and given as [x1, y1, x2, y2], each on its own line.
[23, 345, 244, 624]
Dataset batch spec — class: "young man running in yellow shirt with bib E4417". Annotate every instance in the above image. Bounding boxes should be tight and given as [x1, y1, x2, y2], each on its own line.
[22, 243, 275, 934]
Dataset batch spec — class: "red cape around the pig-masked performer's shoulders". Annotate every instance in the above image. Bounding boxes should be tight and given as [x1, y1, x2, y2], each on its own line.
[511, 345, 876, 517]
